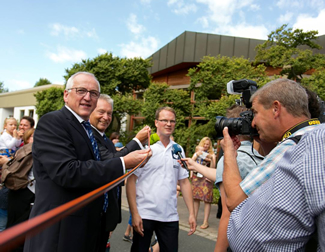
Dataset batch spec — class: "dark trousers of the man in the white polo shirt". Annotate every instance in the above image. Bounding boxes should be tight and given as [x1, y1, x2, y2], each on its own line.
[131, 219, 179, 252]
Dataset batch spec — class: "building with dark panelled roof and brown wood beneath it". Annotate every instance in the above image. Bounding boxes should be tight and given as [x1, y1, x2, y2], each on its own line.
[130, 31, 325, 129]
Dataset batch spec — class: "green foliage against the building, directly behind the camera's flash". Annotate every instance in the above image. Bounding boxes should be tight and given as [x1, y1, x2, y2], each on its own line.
[183, 55, 268, 154]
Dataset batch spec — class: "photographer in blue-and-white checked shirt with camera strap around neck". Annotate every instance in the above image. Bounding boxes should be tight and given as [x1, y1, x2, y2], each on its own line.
[221, 79, 325, 251]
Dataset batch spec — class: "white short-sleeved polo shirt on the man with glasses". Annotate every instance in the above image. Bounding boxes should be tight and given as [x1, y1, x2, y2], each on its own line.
[134, 141, 188, 222]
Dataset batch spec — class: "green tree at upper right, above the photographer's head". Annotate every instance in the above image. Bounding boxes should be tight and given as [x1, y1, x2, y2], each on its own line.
[255, 24, 325, 82]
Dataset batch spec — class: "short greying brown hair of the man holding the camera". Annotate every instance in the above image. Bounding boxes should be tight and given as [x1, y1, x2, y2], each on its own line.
[250, 79, 310, 118]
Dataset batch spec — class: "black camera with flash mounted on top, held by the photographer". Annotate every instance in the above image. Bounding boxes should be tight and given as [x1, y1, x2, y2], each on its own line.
[214, 79, 258, 138]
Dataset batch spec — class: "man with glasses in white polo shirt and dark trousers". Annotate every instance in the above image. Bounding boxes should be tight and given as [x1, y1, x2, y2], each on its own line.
[126, 107, 196, 252]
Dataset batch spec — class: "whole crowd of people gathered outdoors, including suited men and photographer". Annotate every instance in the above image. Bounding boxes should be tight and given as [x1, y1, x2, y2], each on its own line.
[0, 72, 325, 252]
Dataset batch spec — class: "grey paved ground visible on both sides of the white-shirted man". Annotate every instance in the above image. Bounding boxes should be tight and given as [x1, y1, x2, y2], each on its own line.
[107, 187, 219, 252]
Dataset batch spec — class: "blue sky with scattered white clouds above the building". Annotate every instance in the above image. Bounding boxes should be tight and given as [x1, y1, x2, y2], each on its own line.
[0, 0, 325, 91]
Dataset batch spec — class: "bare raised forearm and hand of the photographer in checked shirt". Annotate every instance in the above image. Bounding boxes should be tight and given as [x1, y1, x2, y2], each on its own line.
[221, 127, 247, 212]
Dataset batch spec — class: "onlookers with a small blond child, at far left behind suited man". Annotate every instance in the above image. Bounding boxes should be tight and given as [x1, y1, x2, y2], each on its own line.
[0, 116, 35, 251]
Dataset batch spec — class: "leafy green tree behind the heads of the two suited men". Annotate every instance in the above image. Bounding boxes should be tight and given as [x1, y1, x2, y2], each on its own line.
[36, 53, 150, 131]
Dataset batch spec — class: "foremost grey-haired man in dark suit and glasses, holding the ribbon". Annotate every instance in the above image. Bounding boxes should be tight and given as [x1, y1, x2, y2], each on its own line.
[24, 72, 150, 252]
